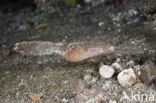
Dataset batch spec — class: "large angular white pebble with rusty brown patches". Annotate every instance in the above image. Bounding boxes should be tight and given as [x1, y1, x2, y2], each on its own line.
[117, 68, 136, 88]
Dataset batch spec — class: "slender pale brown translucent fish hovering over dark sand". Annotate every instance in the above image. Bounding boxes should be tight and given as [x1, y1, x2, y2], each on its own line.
[14, 41, 144, 62]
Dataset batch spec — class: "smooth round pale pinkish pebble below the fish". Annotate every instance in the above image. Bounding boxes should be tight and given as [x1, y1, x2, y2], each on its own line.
[99, 65, 115, 78]
